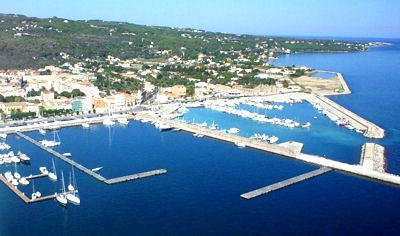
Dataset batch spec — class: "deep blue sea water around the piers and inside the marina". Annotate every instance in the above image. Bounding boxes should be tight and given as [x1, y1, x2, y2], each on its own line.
[0, 39, 400, 235]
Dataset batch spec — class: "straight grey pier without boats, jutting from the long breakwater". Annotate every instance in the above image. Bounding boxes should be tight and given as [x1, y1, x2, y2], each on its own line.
[240, 167, 332, 199]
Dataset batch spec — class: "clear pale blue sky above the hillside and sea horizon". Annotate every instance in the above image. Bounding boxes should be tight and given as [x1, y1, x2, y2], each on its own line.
[0, 0, 400, 38]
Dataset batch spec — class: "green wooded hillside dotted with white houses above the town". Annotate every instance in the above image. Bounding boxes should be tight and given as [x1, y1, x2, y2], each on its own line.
[0, 14, 366, 69]
